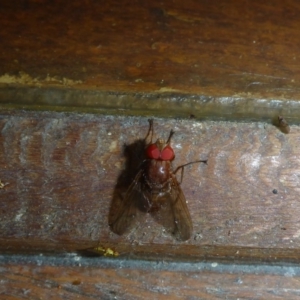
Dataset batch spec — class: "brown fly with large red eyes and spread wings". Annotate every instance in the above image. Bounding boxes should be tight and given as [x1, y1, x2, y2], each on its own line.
[110, 120, 207, 241]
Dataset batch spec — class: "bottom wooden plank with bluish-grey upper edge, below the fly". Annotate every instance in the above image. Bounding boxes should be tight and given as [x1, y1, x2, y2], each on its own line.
[0, 255, 300, 299]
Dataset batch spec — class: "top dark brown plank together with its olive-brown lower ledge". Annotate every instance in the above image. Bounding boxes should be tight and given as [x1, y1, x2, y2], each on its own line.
[0, 0, 300, 125]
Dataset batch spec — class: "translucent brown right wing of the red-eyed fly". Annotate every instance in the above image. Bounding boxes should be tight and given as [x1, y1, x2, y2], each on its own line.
[152, 175, 193, 241]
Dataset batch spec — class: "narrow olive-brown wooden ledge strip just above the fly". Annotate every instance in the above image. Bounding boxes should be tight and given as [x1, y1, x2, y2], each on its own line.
[0, 86, 300, 125]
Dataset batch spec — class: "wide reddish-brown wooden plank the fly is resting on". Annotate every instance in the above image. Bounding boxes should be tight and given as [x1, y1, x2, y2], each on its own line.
[0, 112, 300, 261]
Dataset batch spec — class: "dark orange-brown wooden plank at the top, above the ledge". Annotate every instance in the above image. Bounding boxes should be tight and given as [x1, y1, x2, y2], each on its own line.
[0, 0, 300, 100]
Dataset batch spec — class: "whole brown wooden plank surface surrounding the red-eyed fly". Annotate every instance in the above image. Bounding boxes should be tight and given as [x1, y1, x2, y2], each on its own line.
[0, 0, 300, 299]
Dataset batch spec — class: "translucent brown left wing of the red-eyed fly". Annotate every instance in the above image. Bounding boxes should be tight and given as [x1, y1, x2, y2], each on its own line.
[110, 170, 143, 235]
